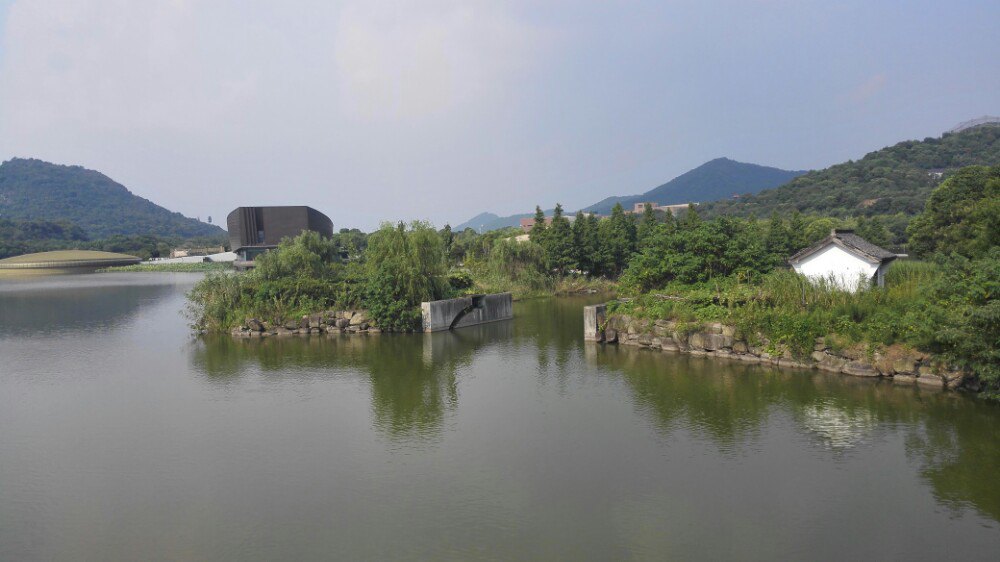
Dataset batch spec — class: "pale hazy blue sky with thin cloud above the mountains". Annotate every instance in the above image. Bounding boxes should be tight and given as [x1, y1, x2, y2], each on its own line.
[0, 0, 1000, 230]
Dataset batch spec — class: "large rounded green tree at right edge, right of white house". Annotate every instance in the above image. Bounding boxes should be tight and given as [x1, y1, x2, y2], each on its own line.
[909, 163, 1000, 257]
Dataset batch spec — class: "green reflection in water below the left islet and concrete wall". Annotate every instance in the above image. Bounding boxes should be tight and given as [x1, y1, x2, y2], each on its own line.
[192, 322, 511, 440]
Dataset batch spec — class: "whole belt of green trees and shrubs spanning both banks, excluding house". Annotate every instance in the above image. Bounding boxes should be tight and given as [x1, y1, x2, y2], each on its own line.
[191, 161, 1000, 398]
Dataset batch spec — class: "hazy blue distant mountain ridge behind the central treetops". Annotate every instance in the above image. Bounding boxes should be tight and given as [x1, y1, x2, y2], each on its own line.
[455, 158, 806, 231]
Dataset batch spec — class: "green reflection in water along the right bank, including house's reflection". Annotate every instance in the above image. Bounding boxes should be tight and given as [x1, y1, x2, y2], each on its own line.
[585, 345, 1000, 521]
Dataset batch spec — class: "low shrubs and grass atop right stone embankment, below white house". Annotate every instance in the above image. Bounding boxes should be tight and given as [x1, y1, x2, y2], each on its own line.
[612, 253, 1000, 398]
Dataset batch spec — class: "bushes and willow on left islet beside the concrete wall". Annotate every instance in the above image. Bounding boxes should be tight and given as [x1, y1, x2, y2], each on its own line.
[188, 222, 452, 331]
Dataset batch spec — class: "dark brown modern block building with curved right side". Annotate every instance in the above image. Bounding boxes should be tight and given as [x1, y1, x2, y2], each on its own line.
[226, 206, 333, 267]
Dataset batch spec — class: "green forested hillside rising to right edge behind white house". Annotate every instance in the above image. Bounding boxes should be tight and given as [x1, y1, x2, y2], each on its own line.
[699, 123, 1000, 217]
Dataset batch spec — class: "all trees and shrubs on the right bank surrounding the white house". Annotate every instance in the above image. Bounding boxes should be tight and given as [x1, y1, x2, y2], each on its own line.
[617, 167, 1000, 398]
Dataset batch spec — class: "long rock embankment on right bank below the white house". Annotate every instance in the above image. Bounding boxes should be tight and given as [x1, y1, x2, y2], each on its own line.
[584, 305, 972, 389]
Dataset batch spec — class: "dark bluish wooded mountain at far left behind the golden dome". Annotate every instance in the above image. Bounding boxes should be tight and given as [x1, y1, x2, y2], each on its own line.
[0, 158, 225, 239]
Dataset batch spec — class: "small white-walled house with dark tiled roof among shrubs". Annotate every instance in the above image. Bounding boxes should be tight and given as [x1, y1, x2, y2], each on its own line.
[788, 229, 896, 291]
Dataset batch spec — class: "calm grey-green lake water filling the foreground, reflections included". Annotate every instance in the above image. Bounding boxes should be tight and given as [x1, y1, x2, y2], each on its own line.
[0, 274, 1000, 561]
